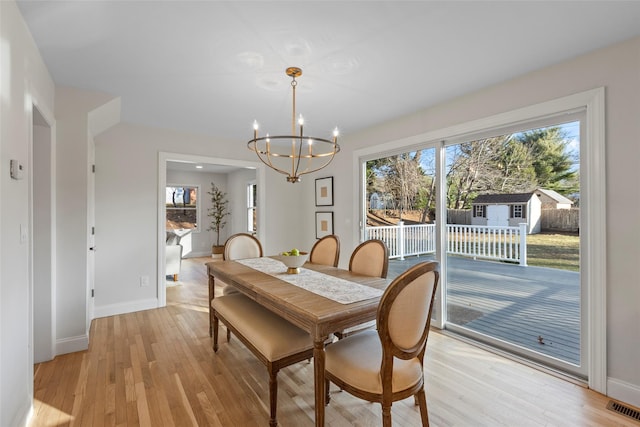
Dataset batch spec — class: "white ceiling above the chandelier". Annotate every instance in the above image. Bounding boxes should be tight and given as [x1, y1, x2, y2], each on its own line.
[18, 0, 640, 145]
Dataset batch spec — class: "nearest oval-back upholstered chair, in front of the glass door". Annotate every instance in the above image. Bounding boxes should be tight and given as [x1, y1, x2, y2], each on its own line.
[325, 262, 439, 427]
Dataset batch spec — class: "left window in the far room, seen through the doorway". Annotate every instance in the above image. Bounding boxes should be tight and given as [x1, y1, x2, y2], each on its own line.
[165, 185, 200, 231]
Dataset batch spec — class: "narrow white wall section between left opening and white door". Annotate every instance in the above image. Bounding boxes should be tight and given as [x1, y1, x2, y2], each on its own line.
[55, 86, 114, 354]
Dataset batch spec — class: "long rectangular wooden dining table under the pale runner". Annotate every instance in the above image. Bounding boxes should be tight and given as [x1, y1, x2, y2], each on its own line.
[207, 261, 391, 426]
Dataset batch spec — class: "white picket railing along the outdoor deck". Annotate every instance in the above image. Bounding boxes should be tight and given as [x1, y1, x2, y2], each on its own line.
[365, 221, 527, 265]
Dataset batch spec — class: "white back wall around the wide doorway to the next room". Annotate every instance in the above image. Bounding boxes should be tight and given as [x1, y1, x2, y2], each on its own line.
[95, 123, 302, 317]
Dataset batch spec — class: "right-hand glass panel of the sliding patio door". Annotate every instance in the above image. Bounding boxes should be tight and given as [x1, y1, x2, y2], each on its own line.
[443, 115, 587, 377]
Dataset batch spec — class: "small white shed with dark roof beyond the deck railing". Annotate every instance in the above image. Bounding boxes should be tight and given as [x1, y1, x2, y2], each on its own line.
[471, 193, 542, 234]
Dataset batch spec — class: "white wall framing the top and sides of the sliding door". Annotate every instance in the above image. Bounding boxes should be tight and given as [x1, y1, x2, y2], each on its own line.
[324, 39, 640, 406]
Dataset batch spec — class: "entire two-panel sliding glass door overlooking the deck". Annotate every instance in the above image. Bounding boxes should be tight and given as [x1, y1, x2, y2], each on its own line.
[363, 111, 587, 378]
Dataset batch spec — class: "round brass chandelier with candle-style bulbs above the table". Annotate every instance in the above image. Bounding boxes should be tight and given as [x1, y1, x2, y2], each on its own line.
[247, 67, 340, 183]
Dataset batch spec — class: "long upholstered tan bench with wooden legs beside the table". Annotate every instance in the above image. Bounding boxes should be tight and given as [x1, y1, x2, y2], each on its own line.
[211, 294, 313, 427]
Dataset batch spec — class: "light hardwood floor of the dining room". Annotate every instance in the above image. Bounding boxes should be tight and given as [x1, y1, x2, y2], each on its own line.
[30, 258, 640, 427]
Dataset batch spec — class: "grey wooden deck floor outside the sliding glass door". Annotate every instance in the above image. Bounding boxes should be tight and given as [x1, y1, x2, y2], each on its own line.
[389, 256, 580, 365]
